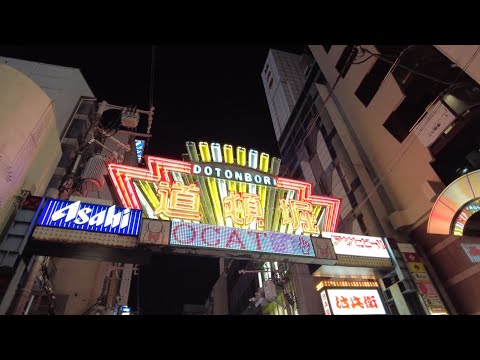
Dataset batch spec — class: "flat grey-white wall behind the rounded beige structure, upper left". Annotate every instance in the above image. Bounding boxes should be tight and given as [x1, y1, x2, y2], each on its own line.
[0, 56, 94, 134]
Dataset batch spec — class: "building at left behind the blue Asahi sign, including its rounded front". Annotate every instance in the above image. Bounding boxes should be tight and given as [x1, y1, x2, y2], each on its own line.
[0, 57, 138, 315]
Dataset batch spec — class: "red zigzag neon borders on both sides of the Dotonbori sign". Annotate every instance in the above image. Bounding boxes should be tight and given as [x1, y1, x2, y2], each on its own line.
[106, 155, 342, 232]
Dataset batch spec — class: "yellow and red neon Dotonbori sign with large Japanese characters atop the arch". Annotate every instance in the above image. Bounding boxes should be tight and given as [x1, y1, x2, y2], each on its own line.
[107, 142, 341, 235]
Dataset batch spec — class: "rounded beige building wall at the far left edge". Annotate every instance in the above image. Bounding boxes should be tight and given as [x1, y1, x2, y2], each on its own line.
[0, 64, 61, 225]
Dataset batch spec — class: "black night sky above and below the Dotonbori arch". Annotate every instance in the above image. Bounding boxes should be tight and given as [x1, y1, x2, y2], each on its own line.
[0, 44, 303, 314]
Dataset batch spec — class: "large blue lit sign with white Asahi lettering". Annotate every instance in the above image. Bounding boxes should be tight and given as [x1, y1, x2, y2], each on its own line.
[37, 199, 142, 236]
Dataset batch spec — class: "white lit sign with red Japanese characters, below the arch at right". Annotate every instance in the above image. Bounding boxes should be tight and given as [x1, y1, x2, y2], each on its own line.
[326, 289, 386, 315]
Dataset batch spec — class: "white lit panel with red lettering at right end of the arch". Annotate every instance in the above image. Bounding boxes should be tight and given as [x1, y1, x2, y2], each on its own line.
[322, 232, 390, 259]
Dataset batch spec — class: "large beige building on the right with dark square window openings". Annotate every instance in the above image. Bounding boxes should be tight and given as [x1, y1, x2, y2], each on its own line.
[300, 45, 480, 314]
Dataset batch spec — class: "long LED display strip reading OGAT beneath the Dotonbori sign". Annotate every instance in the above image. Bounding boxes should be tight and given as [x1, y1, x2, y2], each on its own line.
[170, 221, 315, 257]
